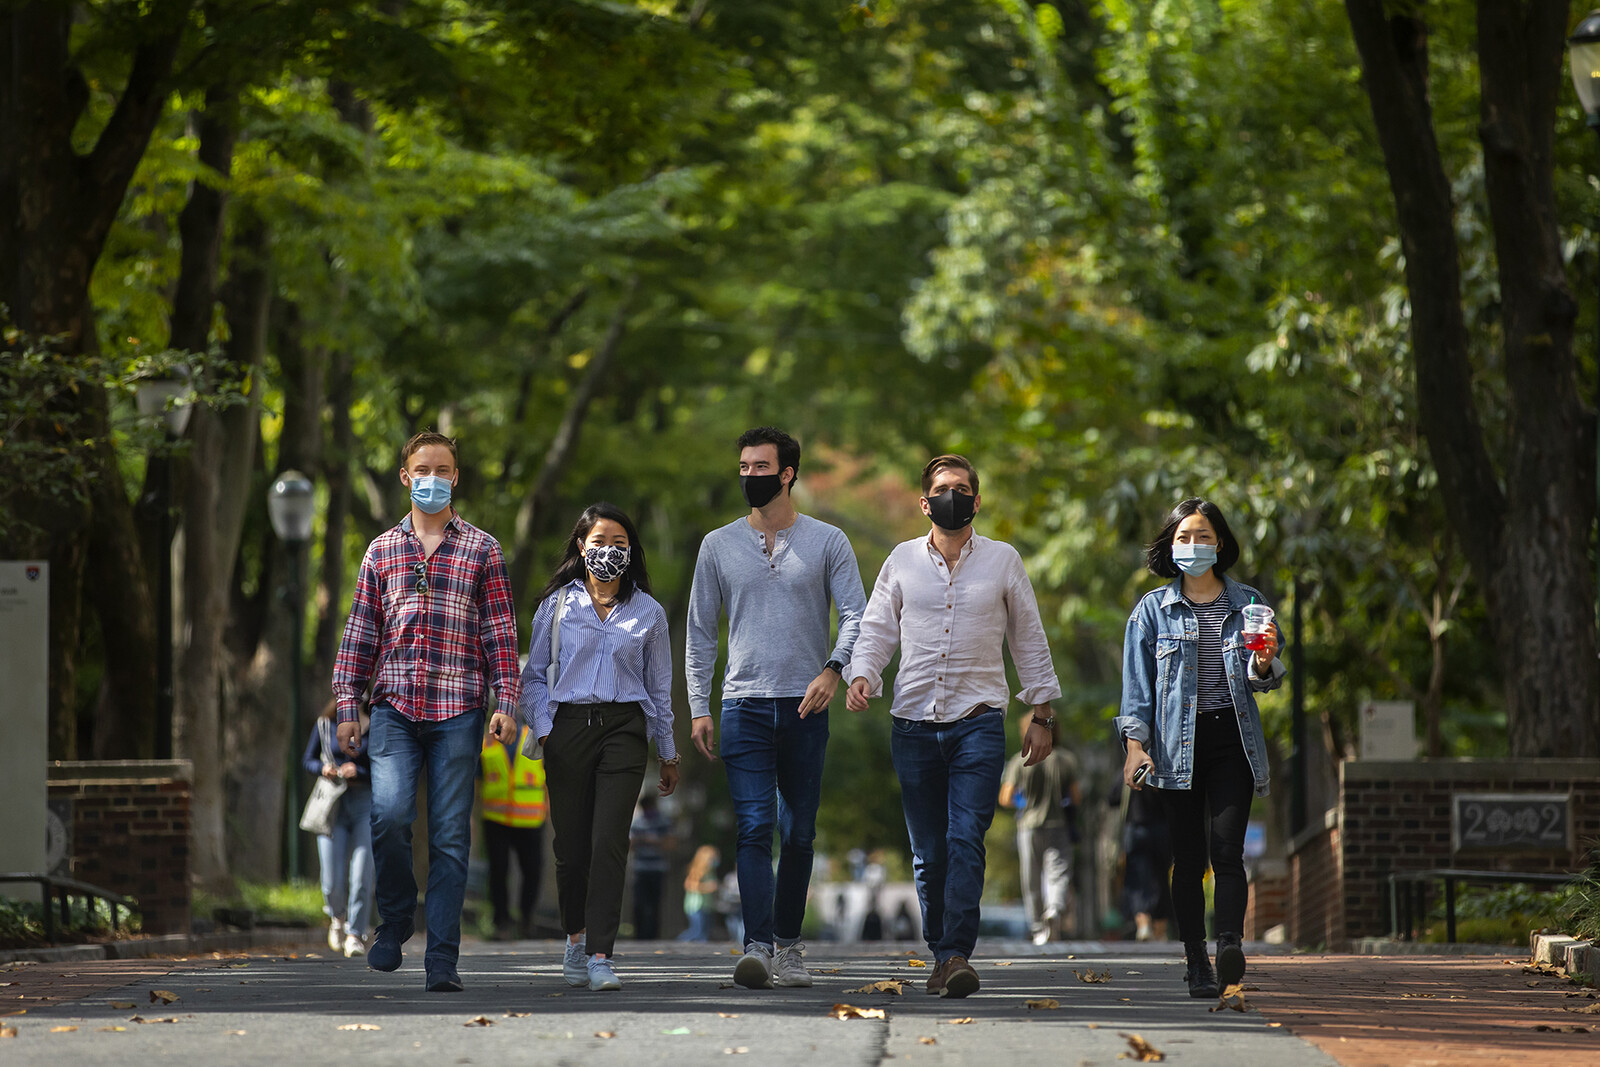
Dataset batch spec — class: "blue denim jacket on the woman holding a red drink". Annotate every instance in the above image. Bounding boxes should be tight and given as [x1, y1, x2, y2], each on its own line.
[1117, 574, 1286, 797]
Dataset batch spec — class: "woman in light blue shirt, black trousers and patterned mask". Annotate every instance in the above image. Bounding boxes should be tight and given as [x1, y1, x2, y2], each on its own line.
[522, 504, 678, 990]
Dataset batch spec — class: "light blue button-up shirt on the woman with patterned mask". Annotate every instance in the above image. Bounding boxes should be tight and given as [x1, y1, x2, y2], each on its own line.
[520, 579, 677, 760]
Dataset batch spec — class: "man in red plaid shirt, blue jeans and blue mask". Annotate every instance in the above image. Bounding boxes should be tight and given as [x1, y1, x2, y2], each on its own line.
[333, 432, 520, 992]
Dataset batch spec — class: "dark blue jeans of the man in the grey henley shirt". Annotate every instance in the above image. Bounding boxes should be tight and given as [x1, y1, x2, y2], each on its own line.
[722, 696, 827, 945]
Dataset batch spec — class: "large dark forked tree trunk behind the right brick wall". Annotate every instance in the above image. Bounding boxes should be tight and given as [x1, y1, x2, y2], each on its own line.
[1346, 0, 1600, 757]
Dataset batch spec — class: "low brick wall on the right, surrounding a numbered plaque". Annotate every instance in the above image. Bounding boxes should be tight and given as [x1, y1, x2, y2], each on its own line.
[1288, 760, 1600, 950]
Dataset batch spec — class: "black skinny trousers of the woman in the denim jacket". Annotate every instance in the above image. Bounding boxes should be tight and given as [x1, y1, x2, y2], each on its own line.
[1162, 710, 1256, 944]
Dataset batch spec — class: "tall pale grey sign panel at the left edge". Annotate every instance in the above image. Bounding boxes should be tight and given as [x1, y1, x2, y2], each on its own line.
[0, 560, 50, 902]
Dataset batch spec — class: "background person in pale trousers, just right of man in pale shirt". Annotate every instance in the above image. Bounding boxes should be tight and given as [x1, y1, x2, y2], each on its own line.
[1000, 715, 1082, 945]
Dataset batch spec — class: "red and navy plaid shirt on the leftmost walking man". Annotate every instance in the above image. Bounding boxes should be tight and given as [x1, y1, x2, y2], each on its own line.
[333, 514, 522, 723]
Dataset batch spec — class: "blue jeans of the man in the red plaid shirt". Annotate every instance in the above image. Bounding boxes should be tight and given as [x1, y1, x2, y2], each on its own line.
[366, 704, 483, 971]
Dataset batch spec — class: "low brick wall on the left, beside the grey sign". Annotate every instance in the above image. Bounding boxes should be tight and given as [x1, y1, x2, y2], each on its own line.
[50, 760, 192, 934]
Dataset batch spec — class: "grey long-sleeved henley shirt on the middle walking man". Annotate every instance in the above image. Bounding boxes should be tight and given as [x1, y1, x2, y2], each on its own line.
[685, 515, 867, 718]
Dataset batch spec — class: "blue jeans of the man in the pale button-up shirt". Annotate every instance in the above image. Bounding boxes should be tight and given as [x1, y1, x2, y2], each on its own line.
[890, 712, 1005, 963]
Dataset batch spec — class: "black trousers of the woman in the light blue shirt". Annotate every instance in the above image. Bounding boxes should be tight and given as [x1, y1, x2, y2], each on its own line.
[544, 704, 648, 957]
